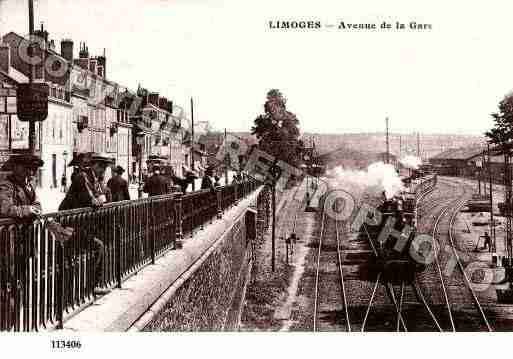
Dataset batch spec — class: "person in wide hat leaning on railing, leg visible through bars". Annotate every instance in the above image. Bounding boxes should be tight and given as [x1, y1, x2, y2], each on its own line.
[59, 153, 113, 295]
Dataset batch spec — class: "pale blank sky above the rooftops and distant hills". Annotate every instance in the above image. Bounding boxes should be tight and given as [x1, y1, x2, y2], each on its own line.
[0, 0, 513, 134]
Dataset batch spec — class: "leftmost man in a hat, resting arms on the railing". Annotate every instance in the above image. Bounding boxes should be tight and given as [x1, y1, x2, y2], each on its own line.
[0, 154, 44, 220]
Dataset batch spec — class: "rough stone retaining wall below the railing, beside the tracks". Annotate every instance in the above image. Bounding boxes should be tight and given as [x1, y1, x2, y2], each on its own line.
[144, 212, 255, 331]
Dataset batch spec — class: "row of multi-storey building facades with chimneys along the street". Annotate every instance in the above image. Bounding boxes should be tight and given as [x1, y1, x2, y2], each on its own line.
[0, 28, 190, 188]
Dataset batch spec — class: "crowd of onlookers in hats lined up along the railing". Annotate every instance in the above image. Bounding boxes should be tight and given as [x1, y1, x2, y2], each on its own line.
[0, 153, 246, 294]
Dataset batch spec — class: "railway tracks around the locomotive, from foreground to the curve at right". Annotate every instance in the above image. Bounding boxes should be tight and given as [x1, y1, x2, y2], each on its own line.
[313, 176, 492, 332]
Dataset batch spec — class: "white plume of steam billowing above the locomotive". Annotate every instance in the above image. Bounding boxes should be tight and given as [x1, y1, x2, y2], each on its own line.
[328, 162, 404, 198]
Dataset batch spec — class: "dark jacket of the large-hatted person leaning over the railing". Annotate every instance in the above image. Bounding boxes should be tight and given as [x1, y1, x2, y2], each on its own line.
[59, 168, 108, 211]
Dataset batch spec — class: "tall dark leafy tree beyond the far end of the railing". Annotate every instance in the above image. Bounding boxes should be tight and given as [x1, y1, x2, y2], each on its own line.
[251, 89, 302, 166]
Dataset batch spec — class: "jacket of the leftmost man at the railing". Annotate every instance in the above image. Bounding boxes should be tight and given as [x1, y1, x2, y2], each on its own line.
[0, 175, 41, 219]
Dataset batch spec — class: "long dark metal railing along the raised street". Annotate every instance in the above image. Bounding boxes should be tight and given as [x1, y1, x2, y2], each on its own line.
[0, 181, 259, 331]
